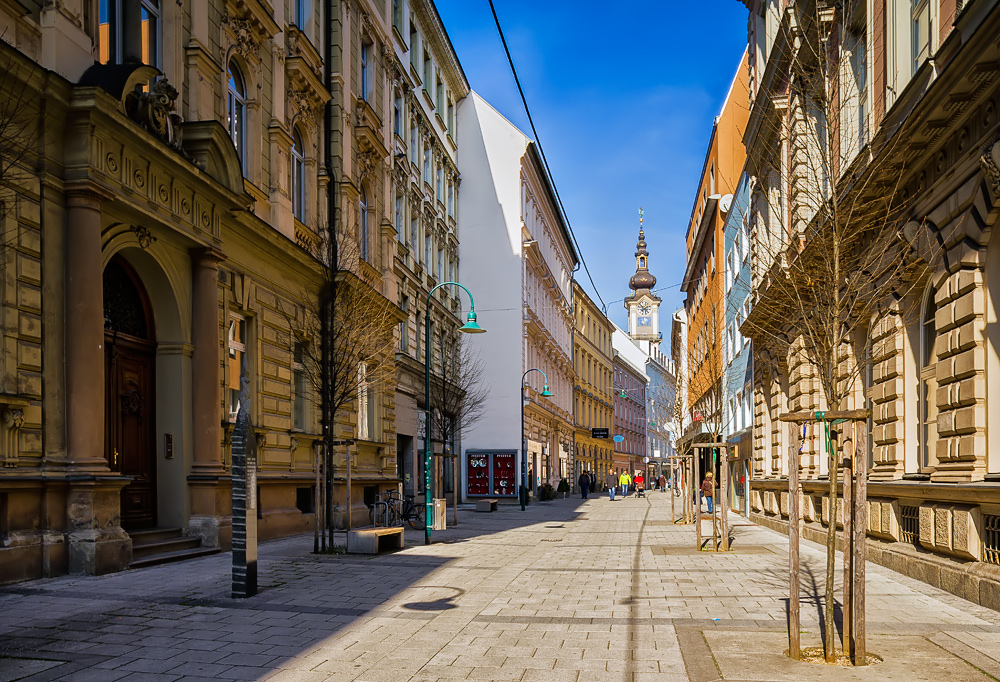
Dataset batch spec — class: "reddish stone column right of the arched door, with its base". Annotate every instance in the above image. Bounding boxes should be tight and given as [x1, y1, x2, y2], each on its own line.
[188, 249, 232, 547]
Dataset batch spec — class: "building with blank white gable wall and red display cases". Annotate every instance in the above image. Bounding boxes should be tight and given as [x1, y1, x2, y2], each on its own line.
[458, 92, 578, 500]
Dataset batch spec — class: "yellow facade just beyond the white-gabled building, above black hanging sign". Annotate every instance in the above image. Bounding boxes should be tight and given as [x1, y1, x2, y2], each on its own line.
[571, 280, 614, 485]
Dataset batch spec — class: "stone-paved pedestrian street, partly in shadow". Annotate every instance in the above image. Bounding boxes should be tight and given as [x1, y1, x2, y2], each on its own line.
[0, 493, 1000, 682]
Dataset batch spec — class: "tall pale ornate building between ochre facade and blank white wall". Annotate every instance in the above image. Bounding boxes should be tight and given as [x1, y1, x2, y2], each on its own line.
[392, 0, 469, 504]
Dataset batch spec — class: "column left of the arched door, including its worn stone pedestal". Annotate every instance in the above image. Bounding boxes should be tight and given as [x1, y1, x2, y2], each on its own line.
[65, 186, 132, 575]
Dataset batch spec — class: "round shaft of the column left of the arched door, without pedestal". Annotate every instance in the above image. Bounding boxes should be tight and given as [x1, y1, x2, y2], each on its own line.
[65, 188, 108, 473]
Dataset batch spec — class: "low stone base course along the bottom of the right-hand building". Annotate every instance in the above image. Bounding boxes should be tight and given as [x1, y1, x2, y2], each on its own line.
[750, 512, 1000, 611]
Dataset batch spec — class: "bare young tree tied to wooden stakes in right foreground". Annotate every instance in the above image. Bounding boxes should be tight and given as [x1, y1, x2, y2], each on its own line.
[741, 0, 923, 660]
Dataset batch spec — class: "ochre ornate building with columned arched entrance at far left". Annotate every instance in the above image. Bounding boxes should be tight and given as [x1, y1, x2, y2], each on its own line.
[0, 0, 397, 582]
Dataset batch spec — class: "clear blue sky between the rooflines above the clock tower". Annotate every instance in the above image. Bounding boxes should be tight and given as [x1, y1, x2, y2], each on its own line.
[437, 0, 747, 332]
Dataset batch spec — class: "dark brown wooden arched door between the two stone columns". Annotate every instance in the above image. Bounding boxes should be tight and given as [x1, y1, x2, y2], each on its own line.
[104, 257, 156, 530]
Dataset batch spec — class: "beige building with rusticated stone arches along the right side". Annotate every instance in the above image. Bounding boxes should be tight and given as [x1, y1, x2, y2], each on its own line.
[744, 0, 1000, 608]
